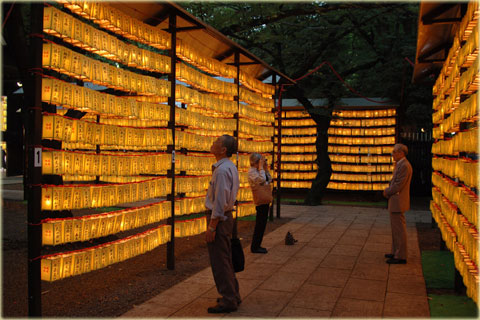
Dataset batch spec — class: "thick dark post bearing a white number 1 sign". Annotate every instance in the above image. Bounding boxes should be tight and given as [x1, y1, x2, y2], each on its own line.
[25, 3, 43, 317]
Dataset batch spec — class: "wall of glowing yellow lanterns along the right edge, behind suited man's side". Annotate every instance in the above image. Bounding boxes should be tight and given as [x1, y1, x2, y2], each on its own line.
[430, 1, 480, 304]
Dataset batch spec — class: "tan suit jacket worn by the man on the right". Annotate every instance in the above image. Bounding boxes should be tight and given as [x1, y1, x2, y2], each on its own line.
[385, 158, 412, 212]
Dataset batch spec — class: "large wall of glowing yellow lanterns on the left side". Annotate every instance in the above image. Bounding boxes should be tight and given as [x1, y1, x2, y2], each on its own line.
[25, 1, 296, 315]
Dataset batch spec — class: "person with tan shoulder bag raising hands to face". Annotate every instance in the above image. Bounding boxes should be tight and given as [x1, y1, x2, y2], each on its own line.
[248, 153, 273, 253]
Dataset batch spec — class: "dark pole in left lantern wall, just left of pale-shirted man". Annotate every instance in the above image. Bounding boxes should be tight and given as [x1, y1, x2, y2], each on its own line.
[167, 12, 177, 270]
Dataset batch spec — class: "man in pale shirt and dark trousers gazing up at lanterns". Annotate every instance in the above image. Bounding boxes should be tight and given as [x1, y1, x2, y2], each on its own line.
[205, 135, 241, 313]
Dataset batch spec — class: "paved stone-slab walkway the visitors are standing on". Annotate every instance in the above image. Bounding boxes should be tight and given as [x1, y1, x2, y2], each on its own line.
[122, 205, 431, 318]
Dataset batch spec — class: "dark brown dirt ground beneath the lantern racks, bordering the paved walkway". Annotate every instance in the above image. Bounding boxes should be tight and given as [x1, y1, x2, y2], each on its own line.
[2, 189, 440, 318]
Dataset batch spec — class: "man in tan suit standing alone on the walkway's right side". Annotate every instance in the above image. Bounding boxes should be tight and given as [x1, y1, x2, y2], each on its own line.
[383, 143, 412, 264]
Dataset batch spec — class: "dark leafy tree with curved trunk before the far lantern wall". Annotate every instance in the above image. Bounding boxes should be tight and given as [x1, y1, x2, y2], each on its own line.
[181, 1, 432, 204]
